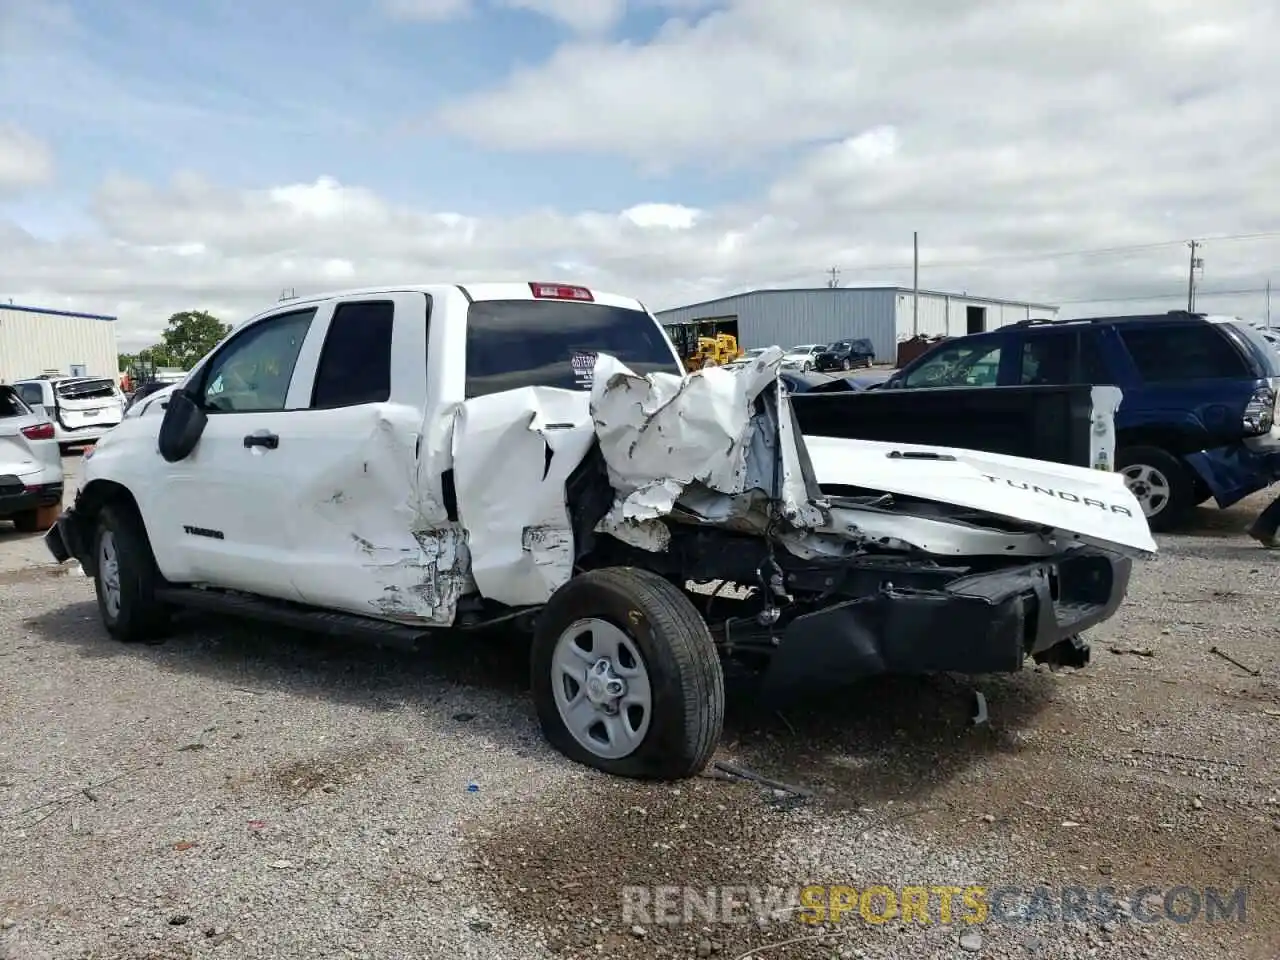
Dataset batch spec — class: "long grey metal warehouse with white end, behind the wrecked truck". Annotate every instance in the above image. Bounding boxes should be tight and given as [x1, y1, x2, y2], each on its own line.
[657, 287, 1057, 364]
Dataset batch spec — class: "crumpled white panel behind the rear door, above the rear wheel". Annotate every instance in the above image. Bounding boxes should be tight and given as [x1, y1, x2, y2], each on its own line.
[453, 387, 594, 607]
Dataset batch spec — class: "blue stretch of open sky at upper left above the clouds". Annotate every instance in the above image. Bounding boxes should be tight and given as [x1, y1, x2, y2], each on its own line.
[0, 0, 767, 233]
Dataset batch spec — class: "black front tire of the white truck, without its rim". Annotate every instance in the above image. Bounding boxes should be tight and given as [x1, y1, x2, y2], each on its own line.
[93, 503, 170, 644]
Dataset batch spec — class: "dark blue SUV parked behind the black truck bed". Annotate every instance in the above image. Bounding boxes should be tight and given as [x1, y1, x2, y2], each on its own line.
[883, 311, 1280, 531]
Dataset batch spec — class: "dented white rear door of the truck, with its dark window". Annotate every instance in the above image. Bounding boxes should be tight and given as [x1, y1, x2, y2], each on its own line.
[271, 292, 435, 623]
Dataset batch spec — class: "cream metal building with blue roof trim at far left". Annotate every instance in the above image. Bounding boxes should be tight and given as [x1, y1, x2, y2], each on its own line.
[0, 303, 119, 383]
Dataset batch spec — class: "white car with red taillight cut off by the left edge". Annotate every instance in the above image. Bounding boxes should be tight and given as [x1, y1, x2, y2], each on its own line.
[0, 384, 63, 534]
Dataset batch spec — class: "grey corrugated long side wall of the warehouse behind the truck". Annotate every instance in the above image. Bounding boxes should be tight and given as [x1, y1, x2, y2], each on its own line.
[657, 287, 910, 362]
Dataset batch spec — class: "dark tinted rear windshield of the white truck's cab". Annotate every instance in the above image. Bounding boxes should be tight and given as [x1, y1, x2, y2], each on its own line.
[466, 300, 681, 399]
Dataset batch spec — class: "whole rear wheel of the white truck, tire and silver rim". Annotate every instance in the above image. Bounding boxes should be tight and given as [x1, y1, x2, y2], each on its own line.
[531, 567, 724, 780]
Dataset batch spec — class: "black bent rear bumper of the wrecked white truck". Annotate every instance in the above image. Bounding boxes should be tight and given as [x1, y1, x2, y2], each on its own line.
[763, 549, 1133, 696]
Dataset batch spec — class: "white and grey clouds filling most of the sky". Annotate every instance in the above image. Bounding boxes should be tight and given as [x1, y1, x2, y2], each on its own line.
[0, 0, 1280, 347]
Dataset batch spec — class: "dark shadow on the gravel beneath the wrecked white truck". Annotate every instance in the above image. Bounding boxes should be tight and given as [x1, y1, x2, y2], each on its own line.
[26, 602, 1056, 806]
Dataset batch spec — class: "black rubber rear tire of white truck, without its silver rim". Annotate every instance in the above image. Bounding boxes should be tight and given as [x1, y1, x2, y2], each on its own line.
[530, 567, 724, 780]
